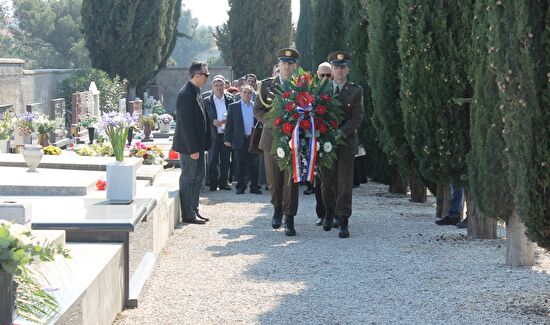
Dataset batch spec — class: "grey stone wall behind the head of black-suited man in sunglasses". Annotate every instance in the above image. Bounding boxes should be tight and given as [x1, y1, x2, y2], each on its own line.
[153, 67, 233, 112]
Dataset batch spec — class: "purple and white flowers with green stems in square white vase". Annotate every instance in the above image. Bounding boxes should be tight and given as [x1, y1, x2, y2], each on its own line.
[101, 112, 136, 161]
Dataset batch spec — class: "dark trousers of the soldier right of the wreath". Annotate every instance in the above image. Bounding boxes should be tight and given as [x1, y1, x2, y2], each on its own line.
[321, 145, 355, 218]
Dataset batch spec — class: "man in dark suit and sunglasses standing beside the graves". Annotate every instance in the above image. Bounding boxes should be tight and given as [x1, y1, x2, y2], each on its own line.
[172, 62, 211, 224]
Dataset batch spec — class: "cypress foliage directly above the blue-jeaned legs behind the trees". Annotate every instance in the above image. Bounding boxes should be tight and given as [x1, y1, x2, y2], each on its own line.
[398, 0, 472, 186]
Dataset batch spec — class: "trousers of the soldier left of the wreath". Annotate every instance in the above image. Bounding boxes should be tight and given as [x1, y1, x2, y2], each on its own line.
[264, 153, 298, 216]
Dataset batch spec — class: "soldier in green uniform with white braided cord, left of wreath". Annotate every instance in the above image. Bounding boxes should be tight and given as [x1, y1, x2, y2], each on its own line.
[254, 48, 300, 236]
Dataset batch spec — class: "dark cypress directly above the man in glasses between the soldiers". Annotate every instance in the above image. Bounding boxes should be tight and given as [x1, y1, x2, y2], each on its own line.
[313, 0, 347, 65]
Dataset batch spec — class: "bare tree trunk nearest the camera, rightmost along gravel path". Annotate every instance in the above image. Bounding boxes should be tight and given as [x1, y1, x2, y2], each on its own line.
[506, 211, 534, 266]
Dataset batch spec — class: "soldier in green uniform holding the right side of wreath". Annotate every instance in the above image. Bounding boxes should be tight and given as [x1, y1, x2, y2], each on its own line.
[321, 51, 365, 238]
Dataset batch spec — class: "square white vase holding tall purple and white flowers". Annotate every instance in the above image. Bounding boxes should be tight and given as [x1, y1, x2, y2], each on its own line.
[106, 159, 139, 204]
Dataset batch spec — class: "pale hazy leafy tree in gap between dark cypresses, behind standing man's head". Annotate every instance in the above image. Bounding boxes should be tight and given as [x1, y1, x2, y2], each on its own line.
[172, 10, 214, 67]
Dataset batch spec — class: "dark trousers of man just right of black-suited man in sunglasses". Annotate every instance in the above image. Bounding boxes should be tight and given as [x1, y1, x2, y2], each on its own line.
[208, 134, 231, 187]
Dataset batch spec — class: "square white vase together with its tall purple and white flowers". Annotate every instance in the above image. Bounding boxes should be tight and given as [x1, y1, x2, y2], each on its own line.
[101, 112, 141, 204]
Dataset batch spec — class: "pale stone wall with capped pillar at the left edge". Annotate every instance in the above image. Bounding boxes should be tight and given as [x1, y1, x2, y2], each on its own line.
[0, 59, 71, 113]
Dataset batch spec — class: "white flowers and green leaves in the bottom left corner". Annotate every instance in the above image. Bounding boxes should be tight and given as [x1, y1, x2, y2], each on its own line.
[0, 220, 70, 323]
